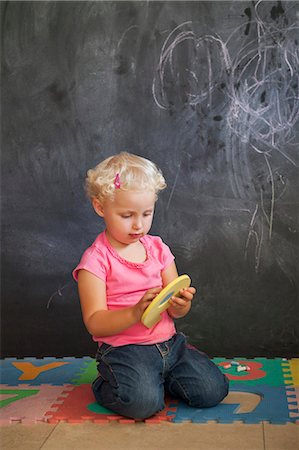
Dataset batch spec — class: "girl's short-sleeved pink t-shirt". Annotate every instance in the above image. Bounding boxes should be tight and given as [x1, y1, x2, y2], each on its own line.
[73, 231, 176, 347]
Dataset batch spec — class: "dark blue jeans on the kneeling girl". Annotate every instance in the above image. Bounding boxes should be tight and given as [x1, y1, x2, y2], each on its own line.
[92, 333, 228, 419]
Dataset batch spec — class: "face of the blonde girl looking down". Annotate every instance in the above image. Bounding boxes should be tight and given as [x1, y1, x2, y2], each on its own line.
[93, 189, 156, 245]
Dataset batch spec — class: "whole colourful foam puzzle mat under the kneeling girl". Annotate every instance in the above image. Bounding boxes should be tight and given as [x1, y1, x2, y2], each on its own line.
[0, 357, 299, 425]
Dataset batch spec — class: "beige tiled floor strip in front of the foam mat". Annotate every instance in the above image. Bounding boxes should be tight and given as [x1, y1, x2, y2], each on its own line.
[0, 423, 299, 450]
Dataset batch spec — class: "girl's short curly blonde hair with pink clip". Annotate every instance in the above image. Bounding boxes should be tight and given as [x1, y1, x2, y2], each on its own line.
[86, 152, 166, 202]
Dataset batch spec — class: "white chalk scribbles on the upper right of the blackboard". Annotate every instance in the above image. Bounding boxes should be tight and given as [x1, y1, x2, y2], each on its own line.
[152, 0, 299, 271]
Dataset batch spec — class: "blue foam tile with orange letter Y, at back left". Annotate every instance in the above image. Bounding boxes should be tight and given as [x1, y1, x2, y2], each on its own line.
[0, 357, 93, 386]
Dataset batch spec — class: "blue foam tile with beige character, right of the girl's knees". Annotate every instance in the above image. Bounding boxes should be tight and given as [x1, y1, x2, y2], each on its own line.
[172, 385, 296, 424]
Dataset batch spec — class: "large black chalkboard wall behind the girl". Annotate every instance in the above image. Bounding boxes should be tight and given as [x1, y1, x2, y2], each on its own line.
[1, 1, 299, 357]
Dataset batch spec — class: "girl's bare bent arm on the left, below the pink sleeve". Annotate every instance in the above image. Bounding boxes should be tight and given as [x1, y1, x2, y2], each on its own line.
[78, 269, 161, 336]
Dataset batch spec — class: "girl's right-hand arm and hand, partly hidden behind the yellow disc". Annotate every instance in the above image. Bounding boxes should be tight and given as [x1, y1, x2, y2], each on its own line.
[162, 262, 196, 319]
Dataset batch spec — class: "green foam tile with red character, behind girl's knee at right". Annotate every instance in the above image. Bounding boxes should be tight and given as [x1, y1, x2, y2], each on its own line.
[213, 357, 285, 386]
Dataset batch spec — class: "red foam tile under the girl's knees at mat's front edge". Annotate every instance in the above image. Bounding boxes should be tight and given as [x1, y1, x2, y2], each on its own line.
[46, 384, 176, 423]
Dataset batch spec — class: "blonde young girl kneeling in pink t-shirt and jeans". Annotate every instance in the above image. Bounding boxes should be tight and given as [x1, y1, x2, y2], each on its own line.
[74, 152, 228, 419]
